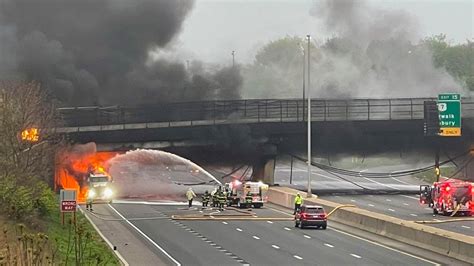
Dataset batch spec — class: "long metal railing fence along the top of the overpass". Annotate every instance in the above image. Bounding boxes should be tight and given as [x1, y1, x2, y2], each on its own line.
[59, 98, 474, 127]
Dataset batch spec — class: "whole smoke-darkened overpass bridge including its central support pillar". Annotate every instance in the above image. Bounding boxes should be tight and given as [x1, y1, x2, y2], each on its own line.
[57, 98, 474, 183]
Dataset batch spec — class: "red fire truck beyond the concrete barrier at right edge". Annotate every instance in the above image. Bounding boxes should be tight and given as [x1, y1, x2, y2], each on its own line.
[420, 179, 474, 215]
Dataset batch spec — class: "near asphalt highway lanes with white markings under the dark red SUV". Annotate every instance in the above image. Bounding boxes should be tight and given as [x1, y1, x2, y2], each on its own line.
[81, 201, 463, 265]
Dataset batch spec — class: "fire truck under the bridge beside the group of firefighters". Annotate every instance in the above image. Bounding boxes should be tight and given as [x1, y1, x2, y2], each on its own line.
[225, 180, 268, 208]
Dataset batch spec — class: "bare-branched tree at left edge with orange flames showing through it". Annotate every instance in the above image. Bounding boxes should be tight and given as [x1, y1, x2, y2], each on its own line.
[0, 82, 60, 218]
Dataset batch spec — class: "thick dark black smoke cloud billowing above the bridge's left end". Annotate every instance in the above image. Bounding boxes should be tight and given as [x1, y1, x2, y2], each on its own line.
[0, 0, 241, 105]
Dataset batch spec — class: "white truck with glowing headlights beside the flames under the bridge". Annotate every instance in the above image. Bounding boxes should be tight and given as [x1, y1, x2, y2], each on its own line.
[87, 174, 114, 203]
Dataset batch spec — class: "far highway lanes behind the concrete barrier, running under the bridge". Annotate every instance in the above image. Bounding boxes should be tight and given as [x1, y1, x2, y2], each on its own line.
[275, 157, 474, 236]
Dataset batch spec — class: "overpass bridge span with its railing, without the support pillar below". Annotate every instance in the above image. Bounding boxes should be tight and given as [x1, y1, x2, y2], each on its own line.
[57, 98, 474, 143]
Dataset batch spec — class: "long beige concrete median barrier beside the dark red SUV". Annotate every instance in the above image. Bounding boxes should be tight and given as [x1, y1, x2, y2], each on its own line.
[268, 187, 474, 263]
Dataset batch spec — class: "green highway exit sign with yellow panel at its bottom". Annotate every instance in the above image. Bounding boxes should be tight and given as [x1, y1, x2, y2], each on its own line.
[438, 93, 461, 137]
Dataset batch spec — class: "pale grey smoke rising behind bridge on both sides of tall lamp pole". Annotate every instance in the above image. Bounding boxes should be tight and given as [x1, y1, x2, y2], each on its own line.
[242, 0, 462, 99]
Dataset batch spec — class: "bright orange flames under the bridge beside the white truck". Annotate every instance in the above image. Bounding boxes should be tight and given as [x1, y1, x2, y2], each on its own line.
[55, 151, 118, 202]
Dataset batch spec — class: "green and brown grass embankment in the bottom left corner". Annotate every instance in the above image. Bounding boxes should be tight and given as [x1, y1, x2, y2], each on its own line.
[0, 203, 120, 265]
